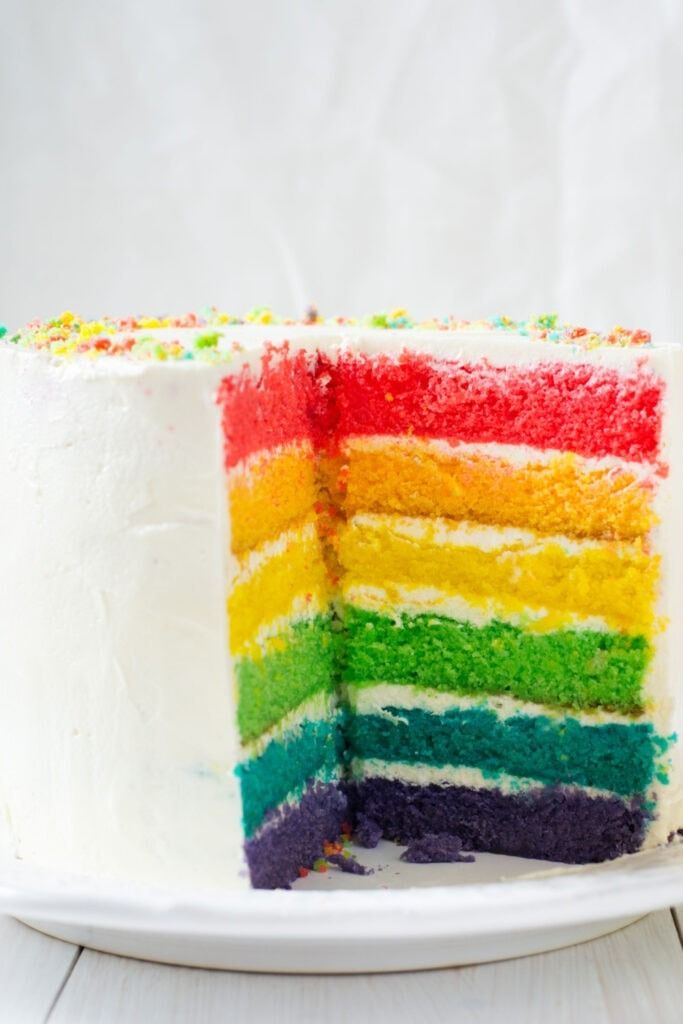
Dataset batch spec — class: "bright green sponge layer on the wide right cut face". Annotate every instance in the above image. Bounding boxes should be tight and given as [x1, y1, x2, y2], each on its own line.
[343, 605, 651, 715]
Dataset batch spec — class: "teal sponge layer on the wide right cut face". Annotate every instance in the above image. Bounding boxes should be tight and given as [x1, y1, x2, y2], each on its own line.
[347, 707, 668, 796]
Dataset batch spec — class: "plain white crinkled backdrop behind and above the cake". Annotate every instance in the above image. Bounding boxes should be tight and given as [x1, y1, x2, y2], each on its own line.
[0, 0, 683, 340]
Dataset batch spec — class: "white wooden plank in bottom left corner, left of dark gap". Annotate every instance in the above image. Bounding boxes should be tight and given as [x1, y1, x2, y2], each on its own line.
[0, 915, 80, 1024]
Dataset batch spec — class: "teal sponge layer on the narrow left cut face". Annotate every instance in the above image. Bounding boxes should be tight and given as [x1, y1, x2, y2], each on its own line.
[238, 716, 343, 837]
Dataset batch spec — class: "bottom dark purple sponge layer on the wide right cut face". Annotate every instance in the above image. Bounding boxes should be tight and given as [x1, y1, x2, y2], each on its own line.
[347, 778, 649, 864]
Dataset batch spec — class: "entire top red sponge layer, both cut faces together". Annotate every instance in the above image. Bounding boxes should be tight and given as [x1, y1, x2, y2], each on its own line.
[218, 346, 664, 467]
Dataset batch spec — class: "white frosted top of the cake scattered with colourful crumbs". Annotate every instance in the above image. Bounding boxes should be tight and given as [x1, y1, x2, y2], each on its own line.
[0, 306, 652, 362]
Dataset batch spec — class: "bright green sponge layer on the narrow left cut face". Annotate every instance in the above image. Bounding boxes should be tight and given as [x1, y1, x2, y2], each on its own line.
[236, 614, 338, 742]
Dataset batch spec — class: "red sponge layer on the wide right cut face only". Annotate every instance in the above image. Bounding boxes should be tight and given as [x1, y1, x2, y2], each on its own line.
[334, 353, 664, 462]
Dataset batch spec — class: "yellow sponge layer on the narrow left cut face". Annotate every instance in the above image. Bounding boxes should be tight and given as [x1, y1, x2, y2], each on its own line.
[227, 521, 330, 657]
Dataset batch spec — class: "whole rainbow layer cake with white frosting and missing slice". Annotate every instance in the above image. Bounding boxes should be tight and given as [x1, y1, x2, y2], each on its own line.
[0, 309, 683, 888]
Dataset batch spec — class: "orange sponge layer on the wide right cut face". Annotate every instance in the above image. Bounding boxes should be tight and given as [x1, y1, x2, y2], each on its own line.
[325, 438, 655, 540]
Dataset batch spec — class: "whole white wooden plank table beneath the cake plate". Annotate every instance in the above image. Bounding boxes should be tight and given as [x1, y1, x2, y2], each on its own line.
[0, 907, 683, 1024]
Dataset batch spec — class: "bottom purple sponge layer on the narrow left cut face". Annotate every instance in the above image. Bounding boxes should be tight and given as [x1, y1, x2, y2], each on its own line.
[245, 783, 348, 889]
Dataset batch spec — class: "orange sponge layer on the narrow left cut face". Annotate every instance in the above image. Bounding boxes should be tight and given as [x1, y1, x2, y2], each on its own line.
[228, 442, 315, 554]
